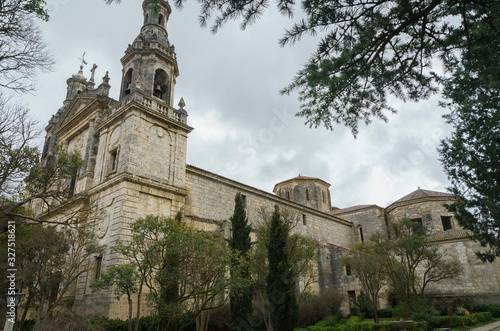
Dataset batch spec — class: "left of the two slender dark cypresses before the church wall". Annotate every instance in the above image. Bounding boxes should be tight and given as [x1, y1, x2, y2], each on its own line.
[229, 193, 253, 330]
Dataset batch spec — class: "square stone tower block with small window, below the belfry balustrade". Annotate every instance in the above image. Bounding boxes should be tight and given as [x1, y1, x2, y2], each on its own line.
[95, 103, 189, 186]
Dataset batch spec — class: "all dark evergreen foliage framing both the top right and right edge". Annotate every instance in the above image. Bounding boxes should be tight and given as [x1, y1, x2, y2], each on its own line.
[105, 0, 500, 261]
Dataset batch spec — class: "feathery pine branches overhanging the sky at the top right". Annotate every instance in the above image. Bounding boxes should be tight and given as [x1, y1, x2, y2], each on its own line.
[149, 0, 499, 135]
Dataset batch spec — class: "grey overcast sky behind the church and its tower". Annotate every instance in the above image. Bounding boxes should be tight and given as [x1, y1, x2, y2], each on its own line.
[23, 0, 450, 208]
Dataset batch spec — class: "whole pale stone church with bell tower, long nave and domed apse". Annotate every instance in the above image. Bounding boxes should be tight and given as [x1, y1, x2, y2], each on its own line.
[36, 0, 500, 318]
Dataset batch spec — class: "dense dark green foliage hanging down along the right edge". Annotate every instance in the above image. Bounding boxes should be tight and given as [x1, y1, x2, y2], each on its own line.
[440, 3, 500, 262]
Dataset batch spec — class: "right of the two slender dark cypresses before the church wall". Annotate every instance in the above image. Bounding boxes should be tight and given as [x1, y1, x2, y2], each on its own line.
[266, 207, 298, 331]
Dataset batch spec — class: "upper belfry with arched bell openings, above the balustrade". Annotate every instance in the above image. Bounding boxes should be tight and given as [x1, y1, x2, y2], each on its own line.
[120, 0, 179, 107]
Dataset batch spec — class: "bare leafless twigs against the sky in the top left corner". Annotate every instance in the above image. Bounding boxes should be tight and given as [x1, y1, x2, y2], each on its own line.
[0, 0, 53, 93]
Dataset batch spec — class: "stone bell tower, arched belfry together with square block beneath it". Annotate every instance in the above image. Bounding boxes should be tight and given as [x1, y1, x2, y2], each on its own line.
[95, 0, 193, 188]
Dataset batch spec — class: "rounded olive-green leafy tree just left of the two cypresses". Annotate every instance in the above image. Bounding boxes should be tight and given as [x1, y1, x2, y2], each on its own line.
[117, 215, 234, 331]
